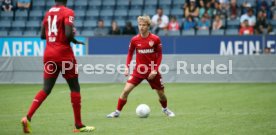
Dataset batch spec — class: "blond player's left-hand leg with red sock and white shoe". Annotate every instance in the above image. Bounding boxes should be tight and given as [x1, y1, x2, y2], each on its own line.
[106, 76, 143, 118]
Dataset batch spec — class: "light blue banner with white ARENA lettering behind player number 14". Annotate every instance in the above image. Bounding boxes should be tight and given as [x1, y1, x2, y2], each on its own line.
[0, 37, 87, 57]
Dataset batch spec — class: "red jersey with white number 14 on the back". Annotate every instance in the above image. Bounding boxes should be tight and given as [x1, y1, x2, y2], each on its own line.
[43, 6, 75, 61]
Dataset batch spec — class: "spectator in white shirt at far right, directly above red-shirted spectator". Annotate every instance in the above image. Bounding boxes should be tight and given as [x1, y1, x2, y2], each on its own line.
[240, 8, 256, 27]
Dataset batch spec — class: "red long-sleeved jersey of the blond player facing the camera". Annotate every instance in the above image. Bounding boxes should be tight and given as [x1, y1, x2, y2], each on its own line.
[126, 33, 162, 78]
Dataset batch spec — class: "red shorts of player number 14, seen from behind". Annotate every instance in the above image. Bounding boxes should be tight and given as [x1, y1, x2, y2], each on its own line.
[44, 60, 78, 79]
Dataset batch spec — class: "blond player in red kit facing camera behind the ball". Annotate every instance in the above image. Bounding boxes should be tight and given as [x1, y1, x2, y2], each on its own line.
[107, 16, 175, 118]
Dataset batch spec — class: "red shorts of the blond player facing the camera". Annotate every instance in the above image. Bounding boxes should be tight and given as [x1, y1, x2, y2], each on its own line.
[127, 74, 164, 90]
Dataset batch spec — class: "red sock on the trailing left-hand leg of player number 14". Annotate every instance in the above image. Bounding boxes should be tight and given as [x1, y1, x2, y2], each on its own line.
[27, 90, 48, 119]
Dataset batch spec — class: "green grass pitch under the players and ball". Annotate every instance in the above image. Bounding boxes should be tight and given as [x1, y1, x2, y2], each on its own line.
[0, 83, 276, 135]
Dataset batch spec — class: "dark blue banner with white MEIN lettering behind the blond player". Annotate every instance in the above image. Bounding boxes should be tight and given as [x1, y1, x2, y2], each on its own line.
[88, 36, 270, 55]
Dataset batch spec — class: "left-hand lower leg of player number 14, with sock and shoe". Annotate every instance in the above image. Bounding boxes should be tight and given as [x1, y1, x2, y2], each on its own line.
[21, 78, 56, 133]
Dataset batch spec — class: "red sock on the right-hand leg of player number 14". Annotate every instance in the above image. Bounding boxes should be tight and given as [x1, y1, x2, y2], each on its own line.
[71, 92, 83, 127]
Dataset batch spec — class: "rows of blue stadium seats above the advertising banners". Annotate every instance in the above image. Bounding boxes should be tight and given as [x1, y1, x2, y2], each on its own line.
[0, 0, 276, 36]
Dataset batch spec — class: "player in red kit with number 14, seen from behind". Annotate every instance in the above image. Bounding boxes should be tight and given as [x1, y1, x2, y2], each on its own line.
[21, 0, 95, 133]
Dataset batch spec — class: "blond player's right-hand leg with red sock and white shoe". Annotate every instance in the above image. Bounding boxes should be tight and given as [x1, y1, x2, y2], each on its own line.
[147, 74, 175, 117]
